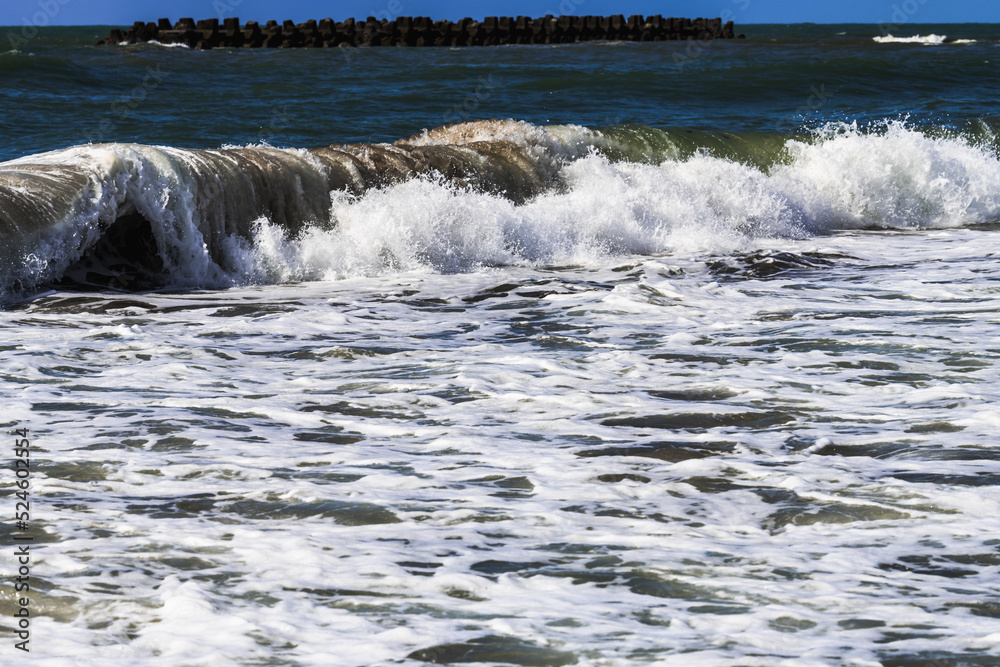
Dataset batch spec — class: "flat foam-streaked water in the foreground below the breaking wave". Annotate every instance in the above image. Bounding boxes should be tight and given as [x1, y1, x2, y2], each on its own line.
[11, 226, 1000, 667]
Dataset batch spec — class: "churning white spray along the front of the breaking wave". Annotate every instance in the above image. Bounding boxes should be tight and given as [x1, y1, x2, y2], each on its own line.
[227, 123, 1000, 282]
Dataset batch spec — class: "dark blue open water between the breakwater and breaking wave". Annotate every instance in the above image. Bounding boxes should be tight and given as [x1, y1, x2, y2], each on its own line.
[0, 25, 1000, 159]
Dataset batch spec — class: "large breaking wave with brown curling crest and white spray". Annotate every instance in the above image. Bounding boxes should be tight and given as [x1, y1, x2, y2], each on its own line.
[0, 121, 1000, 295]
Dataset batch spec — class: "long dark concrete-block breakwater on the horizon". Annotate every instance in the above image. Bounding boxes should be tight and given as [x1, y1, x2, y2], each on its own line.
[98, 14, 743, 49]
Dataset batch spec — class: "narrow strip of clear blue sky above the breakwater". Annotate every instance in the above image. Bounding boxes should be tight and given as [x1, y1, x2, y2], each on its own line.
[0, 0, 1000, 26]
